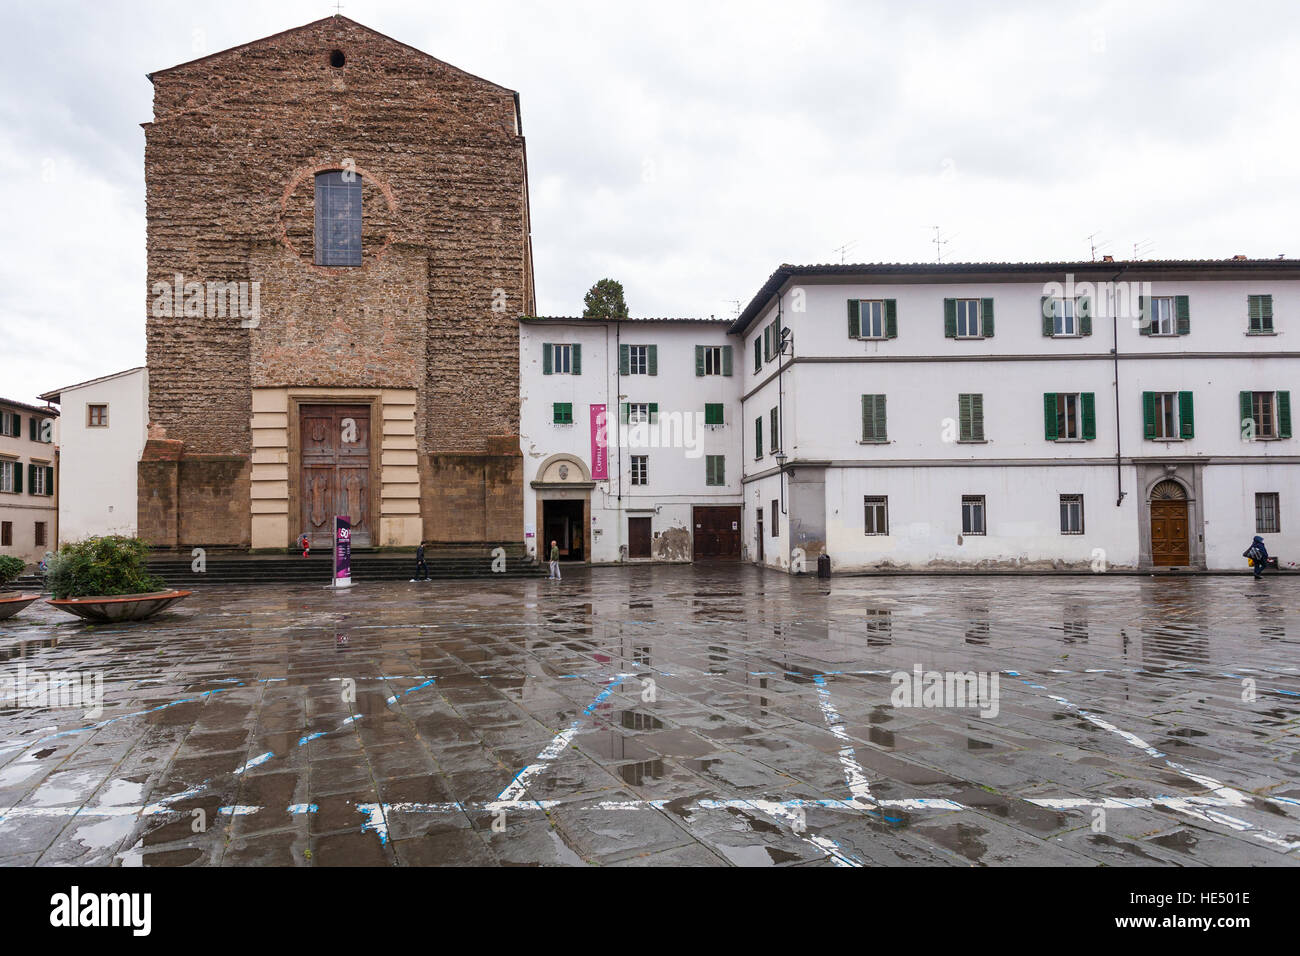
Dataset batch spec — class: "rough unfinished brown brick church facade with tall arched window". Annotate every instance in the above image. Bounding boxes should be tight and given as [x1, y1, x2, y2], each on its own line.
[138, 16, 536, 550]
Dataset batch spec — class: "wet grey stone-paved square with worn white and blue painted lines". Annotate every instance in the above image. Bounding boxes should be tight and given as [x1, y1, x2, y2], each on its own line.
[0, 566, 1300, 866]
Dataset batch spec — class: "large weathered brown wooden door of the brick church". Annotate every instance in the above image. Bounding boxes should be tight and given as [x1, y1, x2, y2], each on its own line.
[298, 405, 372, 548]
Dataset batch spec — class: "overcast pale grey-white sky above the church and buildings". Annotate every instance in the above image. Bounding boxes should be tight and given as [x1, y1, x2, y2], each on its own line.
[0, 0, 1300, 402]
